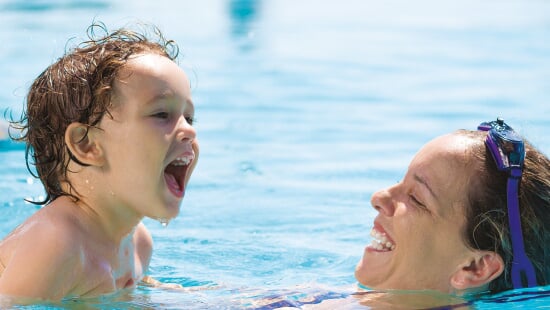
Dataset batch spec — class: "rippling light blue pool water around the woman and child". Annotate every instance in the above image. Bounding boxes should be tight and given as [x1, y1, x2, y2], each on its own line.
[0, 0, 550, 309]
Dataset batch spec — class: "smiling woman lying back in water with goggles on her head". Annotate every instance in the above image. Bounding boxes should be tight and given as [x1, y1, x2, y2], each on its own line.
[355, 119, 550, 296]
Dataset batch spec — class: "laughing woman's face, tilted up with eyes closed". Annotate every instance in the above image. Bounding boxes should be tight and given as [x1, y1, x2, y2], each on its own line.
[355, 134, 484, 292]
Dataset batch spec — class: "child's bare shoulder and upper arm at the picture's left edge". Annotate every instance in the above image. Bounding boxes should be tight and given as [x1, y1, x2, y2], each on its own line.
[0, 196, 88, 298]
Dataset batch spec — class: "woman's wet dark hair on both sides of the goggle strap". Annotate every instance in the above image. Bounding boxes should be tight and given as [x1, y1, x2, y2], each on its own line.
[457, 130, 550, 293]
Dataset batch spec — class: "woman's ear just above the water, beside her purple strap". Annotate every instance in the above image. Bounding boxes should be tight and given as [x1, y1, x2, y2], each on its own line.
[451, 251, 504, 291]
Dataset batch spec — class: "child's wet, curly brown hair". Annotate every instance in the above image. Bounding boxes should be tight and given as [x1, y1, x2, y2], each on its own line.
[10, 22, 179, 205]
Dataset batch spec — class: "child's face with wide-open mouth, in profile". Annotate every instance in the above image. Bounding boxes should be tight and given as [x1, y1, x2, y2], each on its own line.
[99, 54, 198, 220]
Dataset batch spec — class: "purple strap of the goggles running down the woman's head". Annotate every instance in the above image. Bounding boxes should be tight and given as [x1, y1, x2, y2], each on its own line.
[478, 123, 537, 289]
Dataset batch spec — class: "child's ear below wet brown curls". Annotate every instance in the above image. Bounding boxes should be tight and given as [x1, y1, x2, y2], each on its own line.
[65, 123, 104, 166]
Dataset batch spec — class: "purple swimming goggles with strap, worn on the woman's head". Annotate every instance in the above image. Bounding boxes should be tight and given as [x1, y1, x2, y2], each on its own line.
[477, 118, 537, 288]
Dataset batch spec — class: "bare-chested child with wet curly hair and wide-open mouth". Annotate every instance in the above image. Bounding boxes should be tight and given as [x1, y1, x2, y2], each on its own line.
[0, 24, 198, 300]
